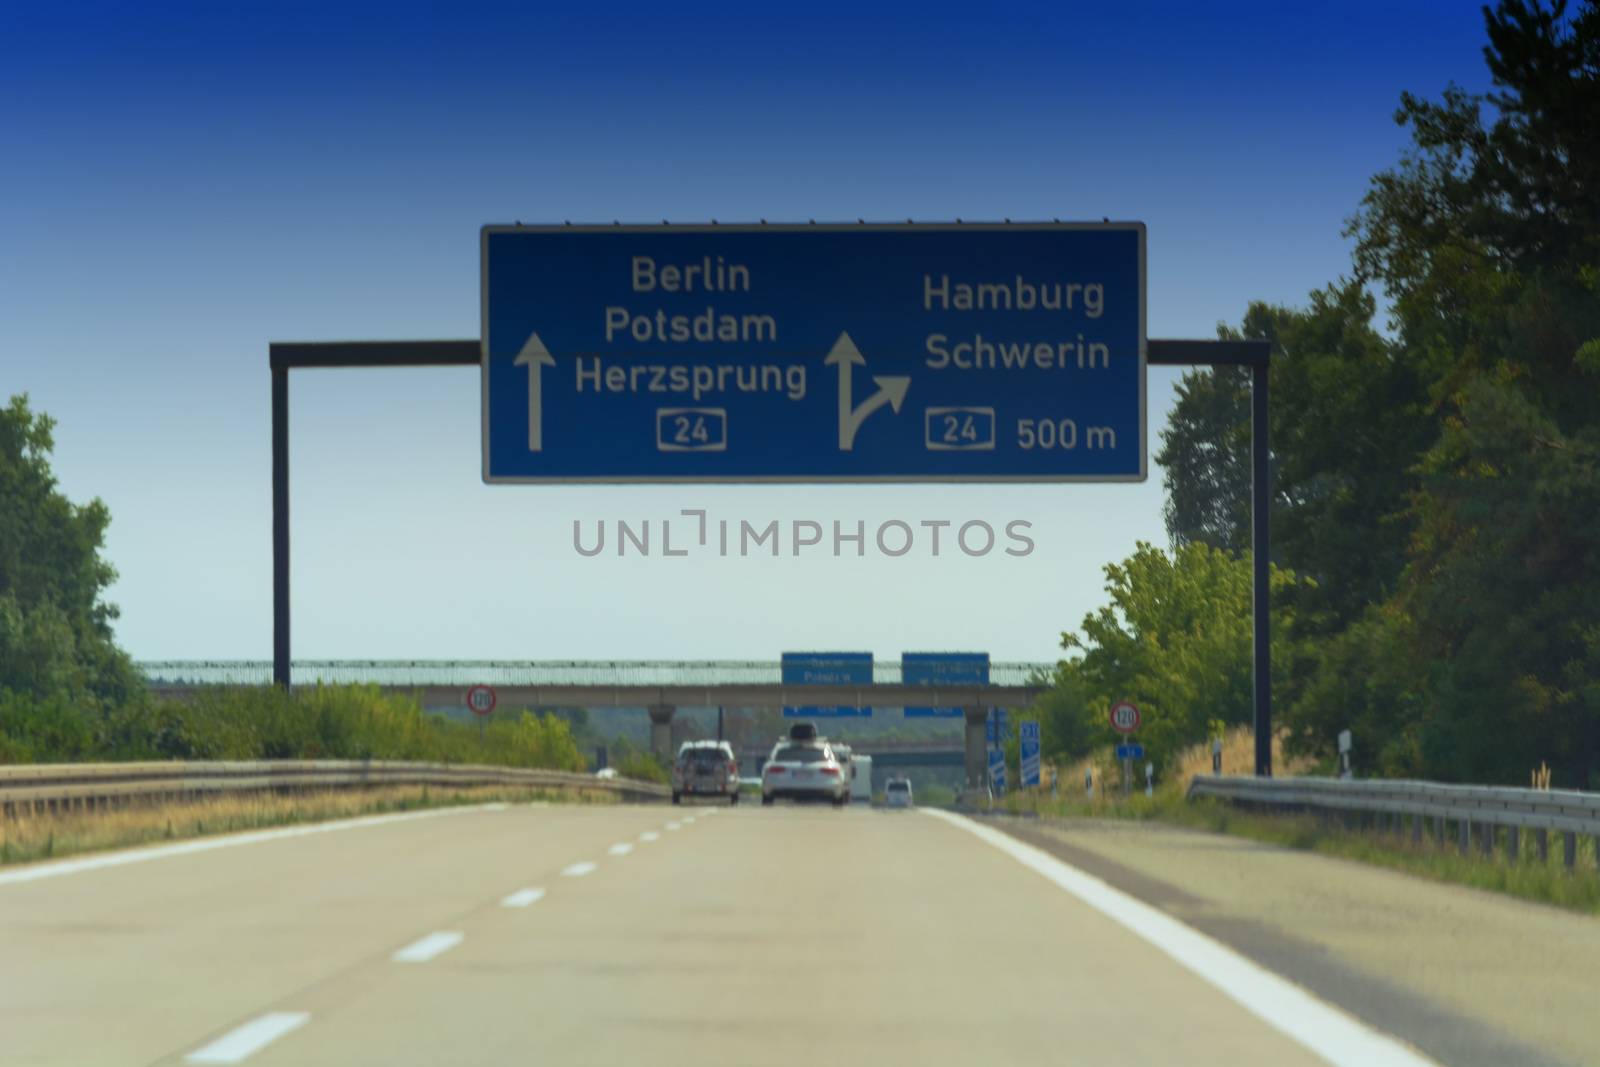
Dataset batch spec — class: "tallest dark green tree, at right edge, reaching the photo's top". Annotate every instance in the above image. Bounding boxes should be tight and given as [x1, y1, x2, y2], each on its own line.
[1350, 0, 1600, 785]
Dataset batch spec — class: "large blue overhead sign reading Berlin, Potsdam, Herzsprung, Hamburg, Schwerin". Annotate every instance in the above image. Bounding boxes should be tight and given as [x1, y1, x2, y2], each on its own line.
[482, 222, 1146, 482]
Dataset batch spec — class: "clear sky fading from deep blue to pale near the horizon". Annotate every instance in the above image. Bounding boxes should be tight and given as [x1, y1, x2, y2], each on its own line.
[0, 0, 1485, 659]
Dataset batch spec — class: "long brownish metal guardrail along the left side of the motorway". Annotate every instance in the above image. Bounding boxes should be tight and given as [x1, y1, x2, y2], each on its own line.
[0, 760, 672, 817]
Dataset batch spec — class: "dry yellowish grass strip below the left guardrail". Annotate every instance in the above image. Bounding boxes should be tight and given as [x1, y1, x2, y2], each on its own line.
[0, 785, 616, 865]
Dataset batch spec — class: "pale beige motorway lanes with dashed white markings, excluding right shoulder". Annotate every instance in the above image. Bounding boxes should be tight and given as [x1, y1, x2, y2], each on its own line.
[0, 806, 1561, 1067]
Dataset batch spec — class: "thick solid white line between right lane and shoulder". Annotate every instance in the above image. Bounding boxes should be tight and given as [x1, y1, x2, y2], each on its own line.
[920, 808, 1438, 1067]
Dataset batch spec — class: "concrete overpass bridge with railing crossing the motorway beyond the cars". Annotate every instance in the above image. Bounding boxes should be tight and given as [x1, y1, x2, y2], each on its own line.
[139, 659, 1053, 785]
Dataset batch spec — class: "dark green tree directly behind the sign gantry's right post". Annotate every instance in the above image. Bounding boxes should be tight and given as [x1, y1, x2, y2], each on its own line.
[1157, 282, 1437, 630]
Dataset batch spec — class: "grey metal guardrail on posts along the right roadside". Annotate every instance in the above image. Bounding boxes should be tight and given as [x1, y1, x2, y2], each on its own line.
[1189, 774, 1600, 867]
